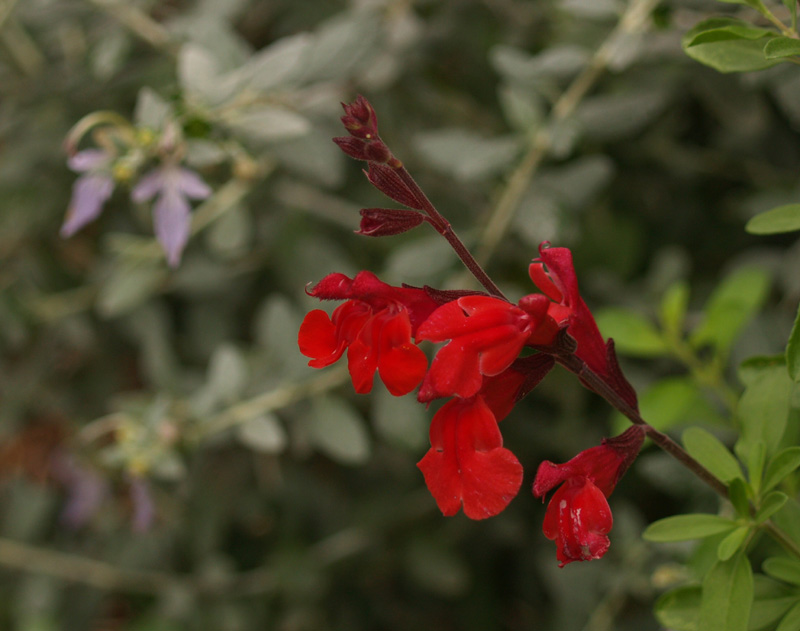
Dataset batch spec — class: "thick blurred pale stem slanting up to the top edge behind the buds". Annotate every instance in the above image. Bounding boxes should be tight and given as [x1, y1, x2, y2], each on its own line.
[476, 0, 658, 265]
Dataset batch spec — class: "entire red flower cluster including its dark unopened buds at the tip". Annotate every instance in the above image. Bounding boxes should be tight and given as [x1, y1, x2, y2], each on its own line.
[298, 97, 643, 565]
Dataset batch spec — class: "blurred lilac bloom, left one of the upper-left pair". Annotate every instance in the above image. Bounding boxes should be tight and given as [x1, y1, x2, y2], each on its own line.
[61, 149, 114, 237]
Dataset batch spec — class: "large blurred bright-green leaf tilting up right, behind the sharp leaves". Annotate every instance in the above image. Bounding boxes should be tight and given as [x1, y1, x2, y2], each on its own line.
[691, 267, 770, 352]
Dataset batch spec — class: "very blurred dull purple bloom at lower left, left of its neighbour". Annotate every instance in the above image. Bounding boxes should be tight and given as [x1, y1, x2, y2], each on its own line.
[51, 450, 109, 528]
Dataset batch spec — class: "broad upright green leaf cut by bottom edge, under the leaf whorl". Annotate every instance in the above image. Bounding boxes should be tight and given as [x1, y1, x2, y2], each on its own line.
[698, 552, 753, 631]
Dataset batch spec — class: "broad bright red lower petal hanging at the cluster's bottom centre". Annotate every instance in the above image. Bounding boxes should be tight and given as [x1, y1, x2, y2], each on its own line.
[417, 396, 522, 519]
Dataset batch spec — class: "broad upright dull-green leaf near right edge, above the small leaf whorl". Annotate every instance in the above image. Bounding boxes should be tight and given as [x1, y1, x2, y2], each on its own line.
[736, 364, 794, 458]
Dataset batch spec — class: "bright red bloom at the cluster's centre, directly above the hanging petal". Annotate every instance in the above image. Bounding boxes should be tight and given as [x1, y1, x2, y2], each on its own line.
[417, 295, 557, 401]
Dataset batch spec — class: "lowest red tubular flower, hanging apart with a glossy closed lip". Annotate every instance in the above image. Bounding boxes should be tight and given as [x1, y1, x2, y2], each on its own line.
[533, 425, 644, 567]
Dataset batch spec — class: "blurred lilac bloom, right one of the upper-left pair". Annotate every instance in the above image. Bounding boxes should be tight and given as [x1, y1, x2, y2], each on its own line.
[131, 165, 211, 267]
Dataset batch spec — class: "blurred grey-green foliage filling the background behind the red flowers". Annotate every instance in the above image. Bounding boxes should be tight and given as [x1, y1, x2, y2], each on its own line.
[0, 0, 800, 631]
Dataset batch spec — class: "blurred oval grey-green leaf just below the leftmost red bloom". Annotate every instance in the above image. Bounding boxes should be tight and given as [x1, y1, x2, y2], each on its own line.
[308, 397, 371, 465]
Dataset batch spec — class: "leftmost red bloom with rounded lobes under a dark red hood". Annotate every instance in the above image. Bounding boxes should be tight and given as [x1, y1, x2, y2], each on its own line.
[298, 272, 437, 396]
